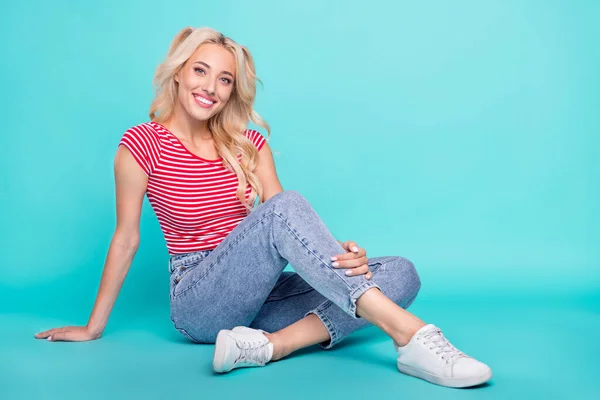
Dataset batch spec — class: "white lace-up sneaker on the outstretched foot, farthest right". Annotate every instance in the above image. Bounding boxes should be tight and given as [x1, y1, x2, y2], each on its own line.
[394, 324, 492, 388]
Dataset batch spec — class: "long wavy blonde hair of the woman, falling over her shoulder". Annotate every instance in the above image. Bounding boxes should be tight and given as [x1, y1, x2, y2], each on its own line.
[150, 27, 271, 210]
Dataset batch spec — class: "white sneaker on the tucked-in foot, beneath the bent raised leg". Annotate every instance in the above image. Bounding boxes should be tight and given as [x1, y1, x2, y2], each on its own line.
[213, 326, 273, 373]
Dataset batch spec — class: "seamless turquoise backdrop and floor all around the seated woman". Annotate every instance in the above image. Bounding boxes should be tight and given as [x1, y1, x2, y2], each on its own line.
[0, 0, 600, 399]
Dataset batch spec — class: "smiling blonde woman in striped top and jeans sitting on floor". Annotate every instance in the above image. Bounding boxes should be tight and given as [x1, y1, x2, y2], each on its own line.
[36, 28, 491, 387]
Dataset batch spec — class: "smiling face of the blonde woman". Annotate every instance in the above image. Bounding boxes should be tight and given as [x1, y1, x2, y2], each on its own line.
[175, 43, 236, 121]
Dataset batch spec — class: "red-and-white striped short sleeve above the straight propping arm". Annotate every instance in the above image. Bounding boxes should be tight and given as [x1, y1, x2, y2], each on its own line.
[119, 124, 160, 176]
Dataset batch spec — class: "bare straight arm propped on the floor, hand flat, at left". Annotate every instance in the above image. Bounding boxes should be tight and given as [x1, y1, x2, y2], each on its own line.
[35, 146, 148, 341]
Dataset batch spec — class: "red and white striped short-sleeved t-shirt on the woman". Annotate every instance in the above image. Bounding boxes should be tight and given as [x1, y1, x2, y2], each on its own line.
[119, 122, 265, 255]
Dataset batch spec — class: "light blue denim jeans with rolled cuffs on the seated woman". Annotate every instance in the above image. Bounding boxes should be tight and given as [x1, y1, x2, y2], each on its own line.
[169, 191, 421, 348]
